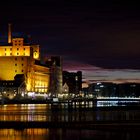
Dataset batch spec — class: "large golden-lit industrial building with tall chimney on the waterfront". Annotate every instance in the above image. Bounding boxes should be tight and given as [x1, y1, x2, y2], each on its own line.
[0, 24, 62, 98]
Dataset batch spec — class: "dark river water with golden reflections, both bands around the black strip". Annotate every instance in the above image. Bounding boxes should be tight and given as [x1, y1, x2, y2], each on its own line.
[0, 104, 140, 140]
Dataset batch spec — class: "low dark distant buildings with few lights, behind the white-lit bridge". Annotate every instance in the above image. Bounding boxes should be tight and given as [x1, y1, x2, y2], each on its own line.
[87, 82, 140, 99]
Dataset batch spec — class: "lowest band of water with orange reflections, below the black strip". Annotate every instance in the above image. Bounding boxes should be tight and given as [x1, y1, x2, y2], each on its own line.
[0, 128, 140, 140]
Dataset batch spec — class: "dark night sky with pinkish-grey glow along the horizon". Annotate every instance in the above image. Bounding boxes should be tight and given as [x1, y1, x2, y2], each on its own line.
[0, 0, 140, 82]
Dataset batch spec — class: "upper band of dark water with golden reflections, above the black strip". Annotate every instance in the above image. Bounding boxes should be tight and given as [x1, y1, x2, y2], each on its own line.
[0, 104, 140, 122]
